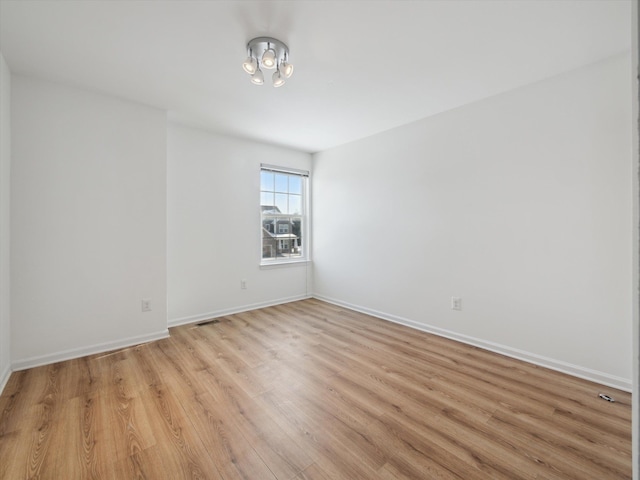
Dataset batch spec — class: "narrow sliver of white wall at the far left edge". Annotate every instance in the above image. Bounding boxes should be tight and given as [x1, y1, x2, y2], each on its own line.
[0, 53, 11, 393]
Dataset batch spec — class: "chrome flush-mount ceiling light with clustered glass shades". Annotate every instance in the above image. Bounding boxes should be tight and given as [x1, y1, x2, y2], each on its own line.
[242, 37, 293, 88]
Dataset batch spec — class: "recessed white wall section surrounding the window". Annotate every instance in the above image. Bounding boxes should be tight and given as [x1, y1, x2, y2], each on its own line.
[167, 124, 311, 325]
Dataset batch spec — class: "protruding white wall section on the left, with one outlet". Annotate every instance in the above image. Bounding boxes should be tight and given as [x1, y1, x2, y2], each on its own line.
[11, 76, 167, 369]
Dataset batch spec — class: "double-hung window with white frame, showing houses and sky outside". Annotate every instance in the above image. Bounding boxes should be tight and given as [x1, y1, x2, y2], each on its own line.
[260, 165, 309, 265]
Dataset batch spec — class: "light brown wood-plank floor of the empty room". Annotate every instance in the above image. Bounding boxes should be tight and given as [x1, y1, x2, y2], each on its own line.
[0, 300, 631, 480]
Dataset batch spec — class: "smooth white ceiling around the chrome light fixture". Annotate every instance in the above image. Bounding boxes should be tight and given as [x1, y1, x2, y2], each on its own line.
[0, 0, 631, 152]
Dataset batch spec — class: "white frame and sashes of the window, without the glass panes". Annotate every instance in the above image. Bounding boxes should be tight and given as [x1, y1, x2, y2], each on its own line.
[259, 164, 311, 267]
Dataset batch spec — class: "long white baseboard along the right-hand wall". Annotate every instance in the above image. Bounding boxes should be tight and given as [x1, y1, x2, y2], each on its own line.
[313, 295, 632, 392]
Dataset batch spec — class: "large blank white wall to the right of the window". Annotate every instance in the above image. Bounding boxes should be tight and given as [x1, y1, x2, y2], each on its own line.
[313, 55, 631, 389]
